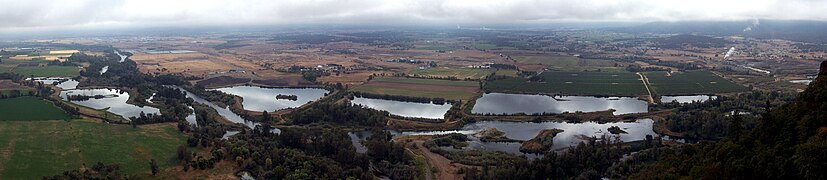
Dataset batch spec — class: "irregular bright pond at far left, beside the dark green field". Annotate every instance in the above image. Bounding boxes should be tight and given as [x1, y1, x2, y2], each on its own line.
[60, 89, 160, 119]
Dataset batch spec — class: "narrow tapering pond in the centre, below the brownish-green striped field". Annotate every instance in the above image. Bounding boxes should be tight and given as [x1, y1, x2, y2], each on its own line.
[350, 97, 451, 119]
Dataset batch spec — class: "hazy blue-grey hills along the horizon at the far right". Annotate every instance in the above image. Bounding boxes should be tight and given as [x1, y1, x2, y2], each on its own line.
[611, 20, 827, 43]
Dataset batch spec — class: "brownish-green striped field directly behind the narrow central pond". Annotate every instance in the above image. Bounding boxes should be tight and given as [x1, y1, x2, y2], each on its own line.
[350, 77, 479, 100]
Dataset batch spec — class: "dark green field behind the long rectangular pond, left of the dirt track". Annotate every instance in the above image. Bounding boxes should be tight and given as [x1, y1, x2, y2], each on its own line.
[483, 71, 647, 96]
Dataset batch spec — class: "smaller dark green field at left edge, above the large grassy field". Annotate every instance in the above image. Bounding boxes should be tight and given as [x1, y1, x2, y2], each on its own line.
[0, 96, 74, 121]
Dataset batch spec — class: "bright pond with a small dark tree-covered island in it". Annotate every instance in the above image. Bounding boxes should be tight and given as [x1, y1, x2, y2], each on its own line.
[215, 86, 328, 112]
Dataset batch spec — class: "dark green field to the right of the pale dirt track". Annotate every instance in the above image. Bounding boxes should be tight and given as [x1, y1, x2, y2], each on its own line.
[644, 71, 748, 95]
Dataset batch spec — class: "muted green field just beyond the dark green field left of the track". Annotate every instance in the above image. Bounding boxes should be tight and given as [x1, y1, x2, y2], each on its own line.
[514, 55, 625, 72]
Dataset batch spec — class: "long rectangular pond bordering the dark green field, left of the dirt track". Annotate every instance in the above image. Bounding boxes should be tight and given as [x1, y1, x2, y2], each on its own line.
[471, 93, 648, 115]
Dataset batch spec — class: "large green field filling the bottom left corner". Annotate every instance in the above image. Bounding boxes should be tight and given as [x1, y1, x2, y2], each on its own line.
[0, 121, 186, 179]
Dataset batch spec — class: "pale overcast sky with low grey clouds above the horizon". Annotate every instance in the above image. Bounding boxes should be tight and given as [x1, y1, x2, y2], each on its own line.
[0, 0, 827, 31]
